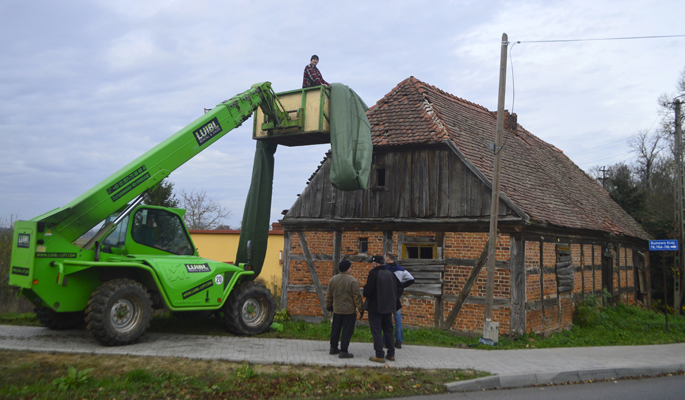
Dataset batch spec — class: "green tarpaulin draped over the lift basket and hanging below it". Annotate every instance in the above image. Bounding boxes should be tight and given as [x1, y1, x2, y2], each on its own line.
[236, 83, 373, 277]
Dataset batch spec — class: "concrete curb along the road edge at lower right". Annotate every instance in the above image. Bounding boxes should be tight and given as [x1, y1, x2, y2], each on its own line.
[445, 364, 685, 392]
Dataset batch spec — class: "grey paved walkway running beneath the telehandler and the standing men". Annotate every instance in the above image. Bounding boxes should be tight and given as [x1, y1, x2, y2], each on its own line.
[0, 325, 685, 392]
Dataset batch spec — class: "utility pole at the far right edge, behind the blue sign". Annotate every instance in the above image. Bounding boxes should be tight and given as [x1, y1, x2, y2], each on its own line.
[673, 99, 685, 315]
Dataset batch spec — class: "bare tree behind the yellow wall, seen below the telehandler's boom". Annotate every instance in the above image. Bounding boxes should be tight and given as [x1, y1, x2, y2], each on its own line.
[180, 189, 231, 230]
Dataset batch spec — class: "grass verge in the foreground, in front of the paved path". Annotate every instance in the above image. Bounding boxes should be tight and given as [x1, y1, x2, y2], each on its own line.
[0, 350, 487, 400]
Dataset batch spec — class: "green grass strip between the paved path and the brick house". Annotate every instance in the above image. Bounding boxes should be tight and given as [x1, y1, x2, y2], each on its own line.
[0, 301, 685, 350]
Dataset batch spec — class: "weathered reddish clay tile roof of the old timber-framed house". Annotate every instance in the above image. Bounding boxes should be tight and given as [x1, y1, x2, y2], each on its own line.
[367, 77, 649, 240]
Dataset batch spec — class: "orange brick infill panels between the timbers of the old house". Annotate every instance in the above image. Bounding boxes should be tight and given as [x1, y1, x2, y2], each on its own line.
[288, 231, 635, 333]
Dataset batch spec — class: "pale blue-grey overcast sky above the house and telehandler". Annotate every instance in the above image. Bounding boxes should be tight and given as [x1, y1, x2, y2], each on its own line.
[0, 0, 685, 226]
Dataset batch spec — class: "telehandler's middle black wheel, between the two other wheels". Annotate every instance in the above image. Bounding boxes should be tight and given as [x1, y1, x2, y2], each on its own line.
[86, 279, 152, 346]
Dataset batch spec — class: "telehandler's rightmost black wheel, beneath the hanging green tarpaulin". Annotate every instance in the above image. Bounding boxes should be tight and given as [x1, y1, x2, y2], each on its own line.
[222, 281, 276, 336]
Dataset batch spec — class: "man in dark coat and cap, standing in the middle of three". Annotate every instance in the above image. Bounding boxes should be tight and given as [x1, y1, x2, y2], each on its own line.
[364, 256, 402, 363]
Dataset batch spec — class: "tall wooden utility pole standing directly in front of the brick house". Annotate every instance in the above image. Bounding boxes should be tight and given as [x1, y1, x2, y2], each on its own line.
[483, 33, 509, 343]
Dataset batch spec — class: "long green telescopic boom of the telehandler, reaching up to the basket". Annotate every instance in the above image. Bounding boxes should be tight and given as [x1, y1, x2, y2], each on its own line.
[32, 82, 298, 242]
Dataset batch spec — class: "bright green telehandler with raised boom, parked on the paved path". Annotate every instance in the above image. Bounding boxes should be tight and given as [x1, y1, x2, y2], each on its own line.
[9, 82, 308, 346]
